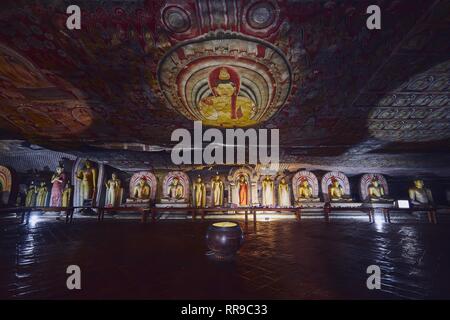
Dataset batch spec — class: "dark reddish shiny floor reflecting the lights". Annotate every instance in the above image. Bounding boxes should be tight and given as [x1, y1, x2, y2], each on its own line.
[0, 212, 450, 299]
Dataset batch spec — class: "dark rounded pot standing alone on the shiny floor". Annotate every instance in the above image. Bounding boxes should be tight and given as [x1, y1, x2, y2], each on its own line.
[206, 222, 244, 260]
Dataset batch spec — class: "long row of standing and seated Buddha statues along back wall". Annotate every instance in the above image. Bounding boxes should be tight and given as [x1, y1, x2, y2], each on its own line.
[18, 160, 433, 208]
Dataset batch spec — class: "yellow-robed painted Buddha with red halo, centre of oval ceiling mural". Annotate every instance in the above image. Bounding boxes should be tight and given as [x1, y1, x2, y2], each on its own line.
[199, 67, 255, 127]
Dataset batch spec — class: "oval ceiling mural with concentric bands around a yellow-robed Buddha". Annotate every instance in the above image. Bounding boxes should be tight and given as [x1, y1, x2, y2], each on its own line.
[158, 32, 292, 128]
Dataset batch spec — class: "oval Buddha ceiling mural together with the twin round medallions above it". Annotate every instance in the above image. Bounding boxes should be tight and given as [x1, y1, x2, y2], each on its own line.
[158, 1, 294, 127]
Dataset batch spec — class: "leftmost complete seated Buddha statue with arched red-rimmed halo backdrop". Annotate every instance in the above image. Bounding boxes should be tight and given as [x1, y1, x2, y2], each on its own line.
[126, 171, 157, 206]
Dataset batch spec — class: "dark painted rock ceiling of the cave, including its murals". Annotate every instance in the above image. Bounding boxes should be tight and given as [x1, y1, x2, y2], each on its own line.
[0, 0, 450, 174]
